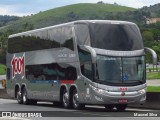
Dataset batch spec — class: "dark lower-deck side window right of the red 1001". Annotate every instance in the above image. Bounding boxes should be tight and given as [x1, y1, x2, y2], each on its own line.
[26, 63, 77, 80]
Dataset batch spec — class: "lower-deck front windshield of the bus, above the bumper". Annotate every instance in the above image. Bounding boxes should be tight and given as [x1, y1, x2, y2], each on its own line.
[97, 55, 145, 83]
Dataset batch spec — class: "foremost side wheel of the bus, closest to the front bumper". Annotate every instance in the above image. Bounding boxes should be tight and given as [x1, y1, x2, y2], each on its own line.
[72, 89, 85, 110]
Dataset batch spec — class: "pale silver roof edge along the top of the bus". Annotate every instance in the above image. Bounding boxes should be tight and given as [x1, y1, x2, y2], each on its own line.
[9, 20, 134, 38]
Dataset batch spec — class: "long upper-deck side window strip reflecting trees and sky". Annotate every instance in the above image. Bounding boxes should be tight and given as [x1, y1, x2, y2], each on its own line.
[8, 27, 74, 53]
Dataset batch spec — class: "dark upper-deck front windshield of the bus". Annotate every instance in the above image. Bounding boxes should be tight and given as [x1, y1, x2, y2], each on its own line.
[90, 23, 143, 51]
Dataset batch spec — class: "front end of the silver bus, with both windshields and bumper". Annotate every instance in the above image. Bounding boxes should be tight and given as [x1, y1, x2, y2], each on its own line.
[76, 21, 146, 110]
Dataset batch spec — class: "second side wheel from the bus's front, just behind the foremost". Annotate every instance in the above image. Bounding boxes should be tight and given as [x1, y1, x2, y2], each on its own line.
[62, 89, 70, 108]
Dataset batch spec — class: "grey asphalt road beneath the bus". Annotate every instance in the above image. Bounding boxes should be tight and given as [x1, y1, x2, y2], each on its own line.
[0, 99, 160, 120]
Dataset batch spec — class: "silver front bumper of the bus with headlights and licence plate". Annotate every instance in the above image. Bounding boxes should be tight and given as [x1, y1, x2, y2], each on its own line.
[91, 86, 146, 104]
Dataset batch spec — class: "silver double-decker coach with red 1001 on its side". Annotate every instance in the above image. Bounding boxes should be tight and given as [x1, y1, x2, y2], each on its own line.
[7, 20, 154, 110]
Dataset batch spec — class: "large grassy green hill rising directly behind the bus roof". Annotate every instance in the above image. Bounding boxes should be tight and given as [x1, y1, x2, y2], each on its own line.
[0, 3, 136, 33]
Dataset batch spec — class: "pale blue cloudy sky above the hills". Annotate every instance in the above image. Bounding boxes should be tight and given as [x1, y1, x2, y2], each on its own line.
[0, 0, 160, 16]
